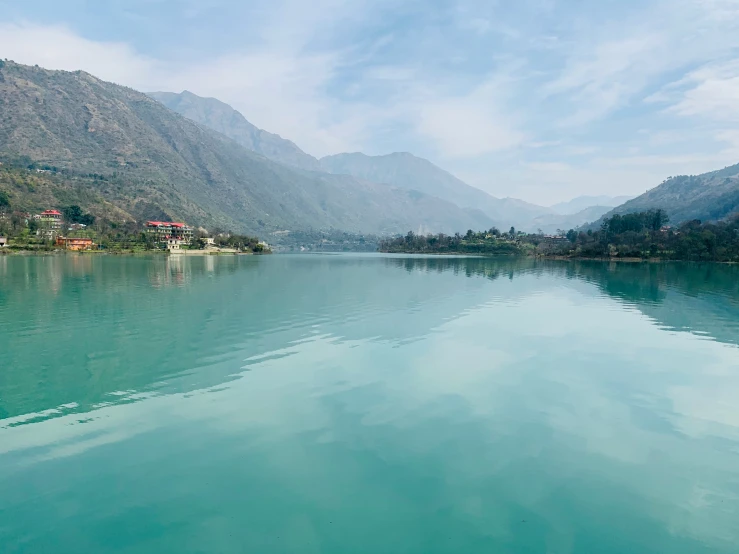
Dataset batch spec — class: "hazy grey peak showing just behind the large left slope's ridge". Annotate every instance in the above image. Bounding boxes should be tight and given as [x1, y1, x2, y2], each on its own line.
[147, 90, 321, 171]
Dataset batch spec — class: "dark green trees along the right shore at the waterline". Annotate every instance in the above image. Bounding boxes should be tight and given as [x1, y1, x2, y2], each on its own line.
[380, 210, 739, 262]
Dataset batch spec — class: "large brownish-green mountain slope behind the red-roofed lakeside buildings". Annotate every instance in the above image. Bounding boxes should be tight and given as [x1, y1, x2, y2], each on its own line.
[0, 62, 490, 234]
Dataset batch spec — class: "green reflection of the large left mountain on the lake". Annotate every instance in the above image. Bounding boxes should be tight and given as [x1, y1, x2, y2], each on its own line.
[0, 252, 548, 417]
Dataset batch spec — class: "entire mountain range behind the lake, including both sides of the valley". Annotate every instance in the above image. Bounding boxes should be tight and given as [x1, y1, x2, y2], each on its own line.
[0, 62, 739, 234]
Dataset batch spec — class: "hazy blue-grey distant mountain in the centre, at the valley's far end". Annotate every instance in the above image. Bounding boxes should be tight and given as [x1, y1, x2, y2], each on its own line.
[320, 152, 550, 228]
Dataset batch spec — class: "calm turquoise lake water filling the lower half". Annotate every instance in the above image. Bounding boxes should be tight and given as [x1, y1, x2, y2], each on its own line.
[0, 255, 739, 554]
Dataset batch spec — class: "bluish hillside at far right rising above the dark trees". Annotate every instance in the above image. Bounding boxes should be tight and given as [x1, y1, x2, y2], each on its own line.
[604, 164, 739, 224]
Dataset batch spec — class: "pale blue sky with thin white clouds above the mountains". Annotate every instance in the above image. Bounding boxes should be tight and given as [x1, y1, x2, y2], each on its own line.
[0, 0, 739, 205]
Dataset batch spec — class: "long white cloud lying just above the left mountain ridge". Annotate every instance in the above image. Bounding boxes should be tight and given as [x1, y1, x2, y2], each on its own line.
[0, 23, 365, 156]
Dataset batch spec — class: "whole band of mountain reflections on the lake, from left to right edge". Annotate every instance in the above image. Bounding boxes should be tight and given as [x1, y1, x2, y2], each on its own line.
[0, 256, 739, 418]
